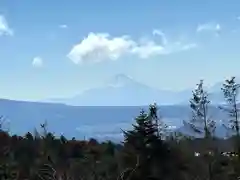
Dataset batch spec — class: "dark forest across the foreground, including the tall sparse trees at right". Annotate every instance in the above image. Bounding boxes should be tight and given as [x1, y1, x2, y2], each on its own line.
[0, 77, 240, 180]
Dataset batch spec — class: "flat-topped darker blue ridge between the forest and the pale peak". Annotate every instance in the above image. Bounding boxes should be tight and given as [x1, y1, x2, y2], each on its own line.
[0, 99, 231, 141]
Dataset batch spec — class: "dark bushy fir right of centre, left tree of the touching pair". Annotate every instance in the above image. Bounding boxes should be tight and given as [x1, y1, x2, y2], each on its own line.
[124, 106, 158, 179]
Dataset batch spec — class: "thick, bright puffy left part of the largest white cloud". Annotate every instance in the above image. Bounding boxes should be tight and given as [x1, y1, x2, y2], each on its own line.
[68, 33, 136, 64]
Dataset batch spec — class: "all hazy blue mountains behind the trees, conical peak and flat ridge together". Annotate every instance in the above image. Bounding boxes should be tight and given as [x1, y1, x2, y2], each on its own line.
[0, 74, 238, 140]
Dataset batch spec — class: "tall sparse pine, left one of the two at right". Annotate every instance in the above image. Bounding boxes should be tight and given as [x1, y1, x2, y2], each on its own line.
[184, 80, 216, 139]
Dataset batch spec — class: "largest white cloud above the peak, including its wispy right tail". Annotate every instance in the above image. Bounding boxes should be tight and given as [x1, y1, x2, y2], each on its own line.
[67, 30, 196, 64]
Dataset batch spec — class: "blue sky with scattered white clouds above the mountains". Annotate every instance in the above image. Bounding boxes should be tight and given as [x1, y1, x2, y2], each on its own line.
[0, 0, 240, 100]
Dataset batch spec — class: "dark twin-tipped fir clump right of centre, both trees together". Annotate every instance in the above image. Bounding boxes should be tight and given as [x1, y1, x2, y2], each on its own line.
[121, 104, 183, 179]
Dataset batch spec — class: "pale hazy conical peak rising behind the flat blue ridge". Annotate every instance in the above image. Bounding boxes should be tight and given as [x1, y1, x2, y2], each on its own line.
[47, 74, 191, 106]
